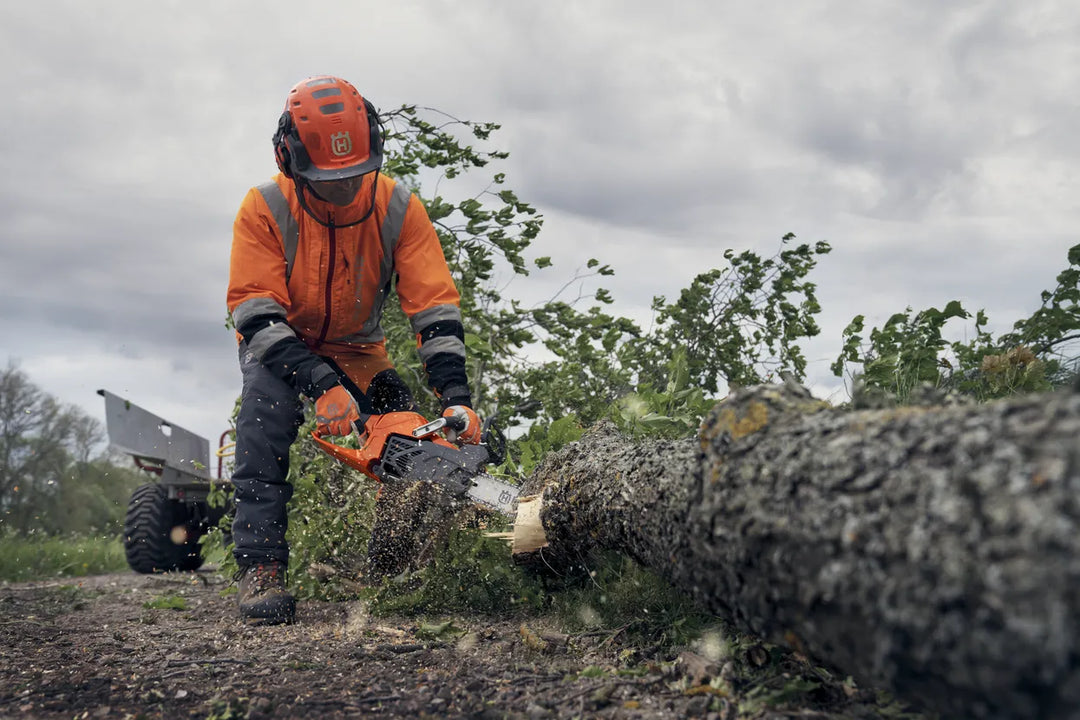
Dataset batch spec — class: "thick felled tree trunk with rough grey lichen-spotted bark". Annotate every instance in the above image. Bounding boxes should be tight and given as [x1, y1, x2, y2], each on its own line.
[514, 385, 1080, 718]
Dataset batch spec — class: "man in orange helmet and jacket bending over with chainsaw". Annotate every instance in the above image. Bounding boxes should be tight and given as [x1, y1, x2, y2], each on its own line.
[228, 76, 481, 624]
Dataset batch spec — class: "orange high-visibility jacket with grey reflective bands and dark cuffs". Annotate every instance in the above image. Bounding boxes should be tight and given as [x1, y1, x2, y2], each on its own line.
[227, 173, 468, 403]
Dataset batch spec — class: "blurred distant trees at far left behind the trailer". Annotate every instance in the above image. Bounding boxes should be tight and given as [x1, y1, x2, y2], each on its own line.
[0, 362, 138, 533]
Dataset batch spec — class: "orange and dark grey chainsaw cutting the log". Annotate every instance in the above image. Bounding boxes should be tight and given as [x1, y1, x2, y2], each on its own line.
[311, 410, 519, 515]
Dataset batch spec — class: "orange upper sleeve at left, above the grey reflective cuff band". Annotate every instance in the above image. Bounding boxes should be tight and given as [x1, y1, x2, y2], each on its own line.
[226, 188, 291, 313]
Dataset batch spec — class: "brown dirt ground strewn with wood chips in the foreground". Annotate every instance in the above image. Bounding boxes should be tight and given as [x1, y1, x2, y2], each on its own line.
[0, 570, 928, 720]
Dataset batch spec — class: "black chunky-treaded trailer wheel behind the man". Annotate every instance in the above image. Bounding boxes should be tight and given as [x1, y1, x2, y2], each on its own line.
[124, 483, 202, 573]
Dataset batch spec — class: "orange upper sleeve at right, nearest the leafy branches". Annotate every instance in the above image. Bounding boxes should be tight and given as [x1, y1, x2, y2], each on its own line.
[394, 195, 461, 317]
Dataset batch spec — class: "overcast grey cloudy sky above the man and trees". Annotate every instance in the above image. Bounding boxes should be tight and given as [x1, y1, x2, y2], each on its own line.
[0, 0, 1080, 468]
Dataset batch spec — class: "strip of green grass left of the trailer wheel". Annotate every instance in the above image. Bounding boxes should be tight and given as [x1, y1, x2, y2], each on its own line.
[0, 534, 127, 582]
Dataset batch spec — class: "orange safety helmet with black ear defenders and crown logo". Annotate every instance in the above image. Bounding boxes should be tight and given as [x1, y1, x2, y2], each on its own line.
[273, 76, 382, 182]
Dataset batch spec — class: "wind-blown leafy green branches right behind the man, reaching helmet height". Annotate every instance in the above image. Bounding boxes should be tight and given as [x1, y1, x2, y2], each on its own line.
[369, 106, 829, 436]
